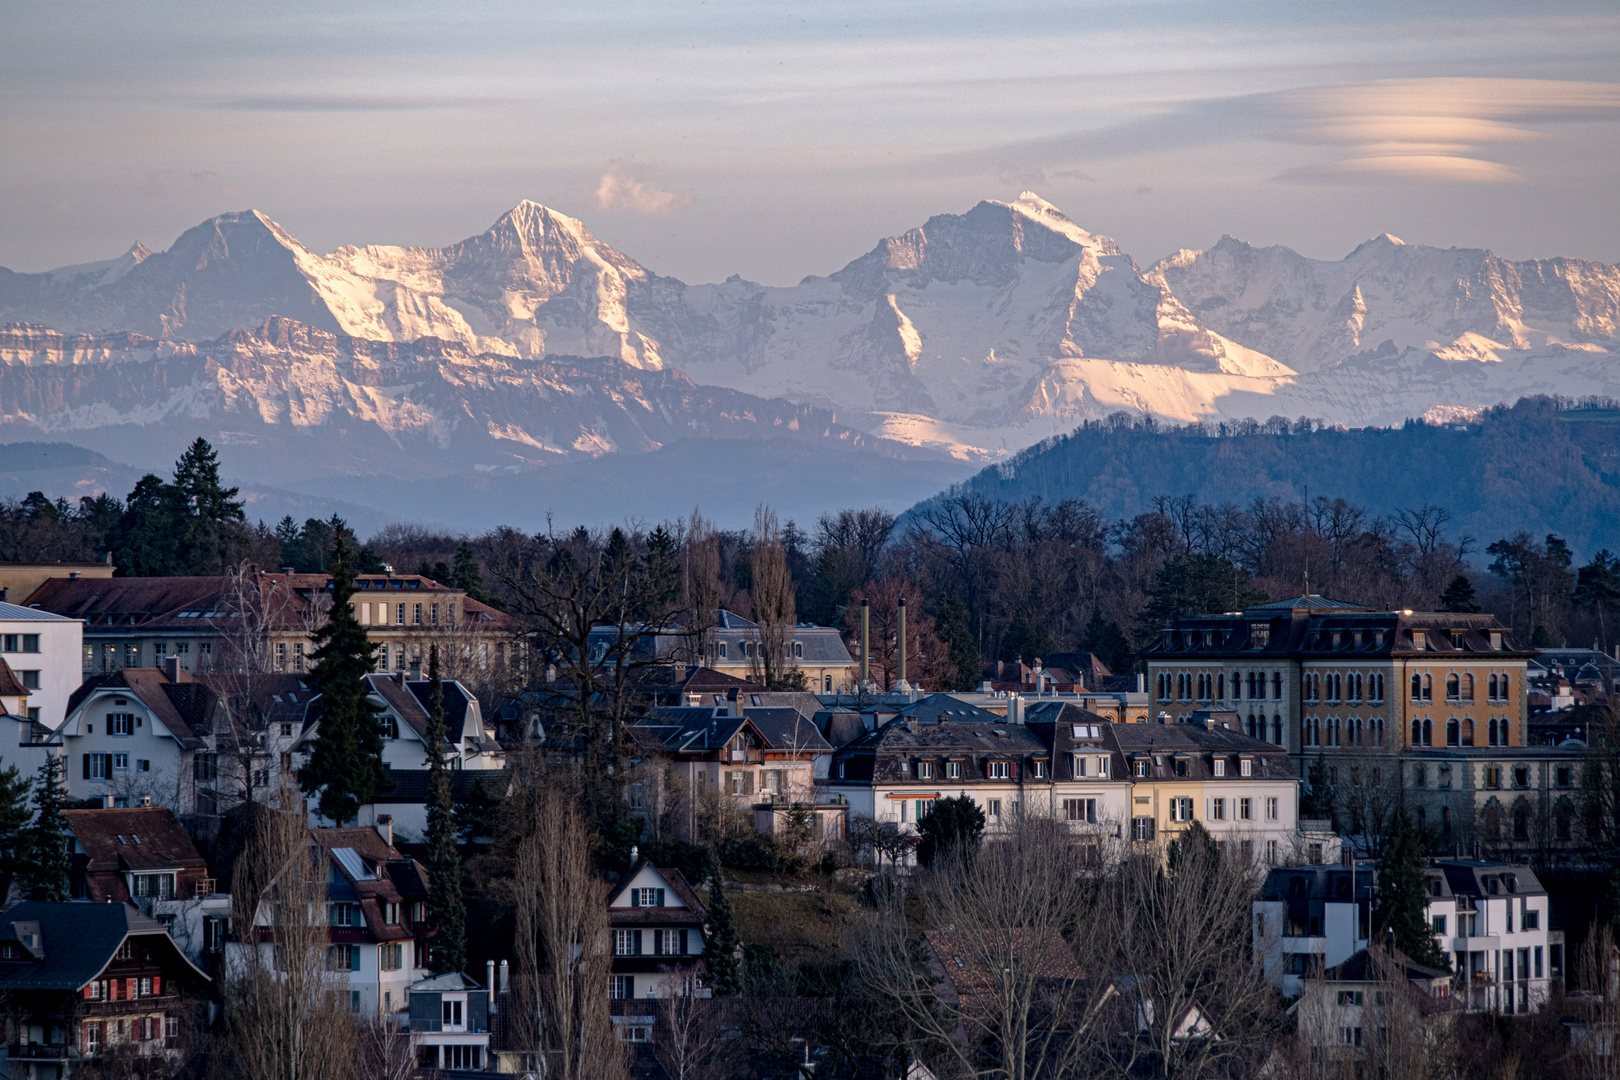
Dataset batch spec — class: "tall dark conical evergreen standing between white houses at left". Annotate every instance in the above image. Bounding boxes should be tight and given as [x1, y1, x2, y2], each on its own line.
[298, 521, 394, 823]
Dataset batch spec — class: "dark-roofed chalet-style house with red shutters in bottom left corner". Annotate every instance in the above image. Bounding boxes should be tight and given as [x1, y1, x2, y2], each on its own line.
[0, 902, 209, 1080]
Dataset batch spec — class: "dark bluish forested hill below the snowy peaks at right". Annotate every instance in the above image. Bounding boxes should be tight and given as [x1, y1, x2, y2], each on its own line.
[917, 398, 1620, 555]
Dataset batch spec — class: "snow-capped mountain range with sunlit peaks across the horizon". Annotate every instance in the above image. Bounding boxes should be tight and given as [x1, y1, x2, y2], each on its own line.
[0, 193, 1620, 468]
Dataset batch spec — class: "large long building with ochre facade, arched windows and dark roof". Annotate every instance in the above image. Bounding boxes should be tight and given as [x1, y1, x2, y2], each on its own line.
[1144, 596, 1534, 764]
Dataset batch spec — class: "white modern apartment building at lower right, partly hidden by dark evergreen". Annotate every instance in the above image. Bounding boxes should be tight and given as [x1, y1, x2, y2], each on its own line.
[1252, 860, 1565, 1014]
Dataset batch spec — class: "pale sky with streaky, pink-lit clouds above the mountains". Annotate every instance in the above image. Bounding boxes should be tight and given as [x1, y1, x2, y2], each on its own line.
[0, 0, 1620, 283]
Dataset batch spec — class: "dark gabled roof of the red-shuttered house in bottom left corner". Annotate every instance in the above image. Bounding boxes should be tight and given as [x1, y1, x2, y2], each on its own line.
[0, 900, 209, 993]
